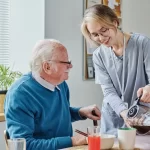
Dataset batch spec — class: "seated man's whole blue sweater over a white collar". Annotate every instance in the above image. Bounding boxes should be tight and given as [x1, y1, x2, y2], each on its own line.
[5, 73, 82, 150]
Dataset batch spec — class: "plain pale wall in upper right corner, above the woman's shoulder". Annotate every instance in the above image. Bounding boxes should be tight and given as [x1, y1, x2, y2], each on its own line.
[122, 0, 150, 37]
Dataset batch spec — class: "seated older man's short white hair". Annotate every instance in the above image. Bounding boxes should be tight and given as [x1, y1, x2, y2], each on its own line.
[30, 39, 63, 73]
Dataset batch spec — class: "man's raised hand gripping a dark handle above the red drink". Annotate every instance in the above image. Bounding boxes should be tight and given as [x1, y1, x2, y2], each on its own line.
[79, 105, 101, 120]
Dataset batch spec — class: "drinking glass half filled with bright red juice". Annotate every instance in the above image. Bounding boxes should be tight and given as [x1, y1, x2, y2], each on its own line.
[87, 126, 100, 150]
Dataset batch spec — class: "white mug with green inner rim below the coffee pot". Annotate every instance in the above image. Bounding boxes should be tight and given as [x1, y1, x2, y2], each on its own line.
[118, 128, 136, 150]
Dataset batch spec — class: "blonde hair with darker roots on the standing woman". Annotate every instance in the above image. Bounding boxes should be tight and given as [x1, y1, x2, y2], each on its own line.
[81, 4, 119, 45]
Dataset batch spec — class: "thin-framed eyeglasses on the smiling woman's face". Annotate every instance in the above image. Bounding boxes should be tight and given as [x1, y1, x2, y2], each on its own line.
[90, 27, 109, 38]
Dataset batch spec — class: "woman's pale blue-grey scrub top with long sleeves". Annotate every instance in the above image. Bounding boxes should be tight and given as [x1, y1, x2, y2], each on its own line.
[93, 34, 150, 135]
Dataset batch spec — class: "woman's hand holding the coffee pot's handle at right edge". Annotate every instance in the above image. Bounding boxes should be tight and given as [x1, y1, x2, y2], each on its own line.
[137, 85, 150, 103]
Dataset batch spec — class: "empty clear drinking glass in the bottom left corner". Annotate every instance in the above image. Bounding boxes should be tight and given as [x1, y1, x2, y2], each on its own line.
[8, 138, 26, 150]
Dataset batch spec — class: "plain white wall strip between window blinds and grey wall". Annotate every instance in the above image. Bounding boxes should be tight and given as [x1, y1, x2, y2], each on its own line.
[10, 0, 45, 73]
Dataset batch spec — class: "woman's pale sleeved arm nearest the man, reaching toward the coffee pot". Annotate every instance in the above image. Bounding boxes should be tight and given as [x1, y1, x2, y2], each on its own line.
[93, 54, 128, 116]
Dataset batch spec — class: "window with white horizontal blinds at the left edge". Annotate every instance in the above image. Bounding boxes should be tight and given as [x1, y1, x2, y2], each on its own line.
[0, 0, 10, 65]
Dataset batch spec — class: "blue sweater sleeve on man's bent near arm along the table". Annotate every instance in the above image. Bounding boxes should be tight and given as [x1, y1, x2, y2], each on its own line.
[5, 92, 72, 150]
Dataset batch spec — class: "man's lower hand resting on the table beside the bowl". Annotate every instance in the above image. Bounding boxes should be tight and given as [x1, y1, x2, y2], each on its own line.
[71, 135, 87, 146]
